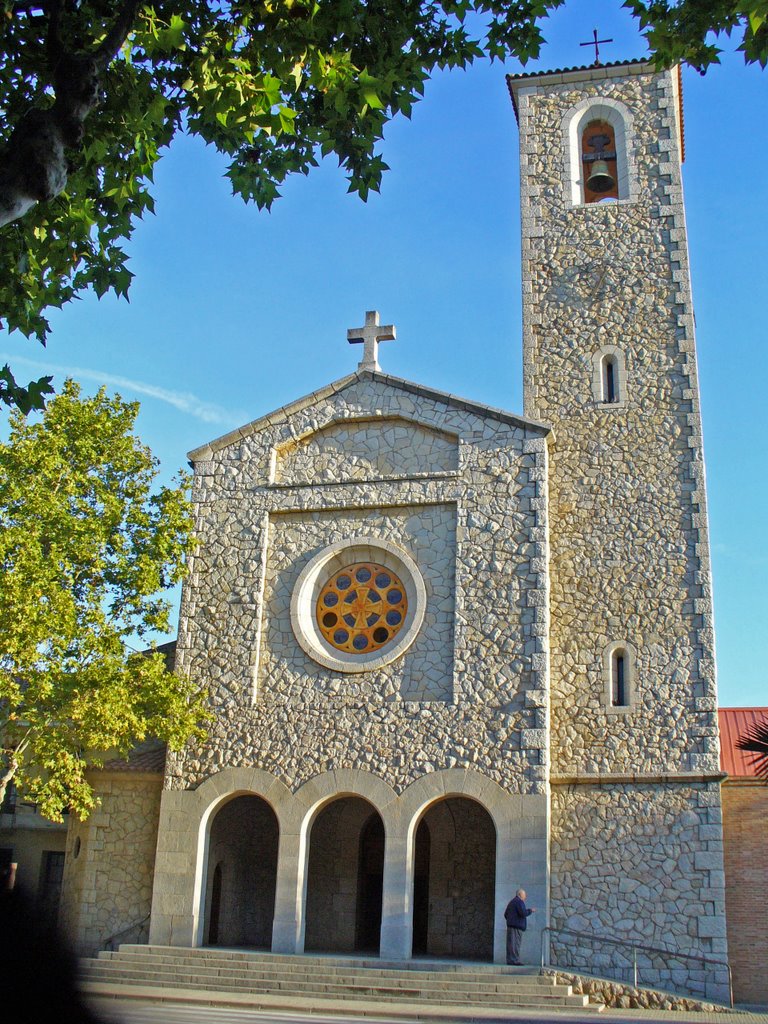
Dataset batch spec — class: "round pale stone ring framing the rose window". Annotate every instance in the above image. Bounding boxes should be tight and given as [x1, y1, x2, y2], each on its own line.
[291, 535, 427, 673]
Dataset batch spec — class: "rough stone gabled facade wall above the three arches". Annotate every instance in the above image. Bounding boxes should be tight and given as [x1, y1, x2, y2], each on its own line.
[166, 372, 548, 793]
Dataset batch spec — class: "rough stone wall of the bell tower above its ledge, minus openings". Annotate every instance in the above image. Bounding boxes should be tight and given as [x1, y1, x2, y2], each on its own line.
[519, 68, 719, 775]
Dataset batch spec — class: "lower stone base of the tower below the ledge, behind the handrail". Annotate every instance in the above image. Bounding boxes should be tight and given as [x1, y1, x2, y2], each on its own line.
[551, 783, 727, 998]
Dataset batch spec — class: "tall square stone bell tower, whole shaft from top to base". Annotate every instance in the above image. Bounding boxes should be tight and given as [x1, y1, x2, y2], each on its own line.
[508, 61, 725, 987]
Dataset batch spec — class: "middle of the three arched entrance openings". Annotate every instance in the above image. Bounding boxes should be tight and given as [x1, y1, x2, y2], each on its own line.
[304, 797, 384, 953]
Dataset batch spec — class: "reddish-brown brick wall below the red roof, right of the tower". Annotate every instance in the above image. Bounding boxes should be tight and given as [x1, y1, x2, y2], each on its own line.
[722, 779, 768, 1004]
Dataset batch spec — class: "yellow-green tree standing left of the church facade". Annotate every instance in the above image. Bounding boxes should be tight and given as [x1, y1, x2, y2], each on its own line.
[0, 382, 203, 820]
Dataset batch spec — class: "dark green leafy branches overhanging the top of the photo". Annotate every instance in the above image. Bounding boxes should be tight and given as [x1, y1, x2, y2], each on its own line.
[0, 0, 768, 409]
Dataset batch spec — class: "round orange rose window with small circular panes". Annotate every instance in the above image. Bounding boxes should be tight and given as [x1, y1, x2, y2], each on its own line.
[315, 562, 408, 654]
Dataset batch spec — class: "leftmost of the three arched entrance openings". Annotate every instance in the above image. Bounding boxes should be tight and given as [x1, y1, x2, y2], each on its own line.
[204, 796, 280, 949]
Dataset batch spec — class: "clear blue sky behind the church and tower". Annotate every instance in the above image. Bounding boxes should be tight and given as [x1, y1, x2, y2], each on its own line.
[0, 0, 768, 707]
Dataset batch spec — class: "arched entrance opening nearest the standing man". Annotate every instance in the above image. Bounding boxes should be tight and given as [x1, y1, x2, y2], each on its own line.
[413, 797, 496, 962]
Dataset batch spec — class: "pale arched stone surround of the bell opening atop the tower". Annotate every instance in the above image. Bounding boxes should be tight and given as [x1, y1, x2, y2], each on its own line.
[562, 96, 638, 208]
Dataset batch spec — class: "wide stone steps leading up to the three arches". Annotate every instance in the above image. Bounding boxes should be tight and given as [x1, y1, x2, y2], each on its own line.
[81, 945, 603, 1020]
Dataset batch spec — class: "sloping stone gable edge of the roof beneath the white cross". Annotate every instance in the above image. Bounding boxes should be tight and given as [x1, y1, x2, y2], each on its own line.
[187, 370, 552, 463]
